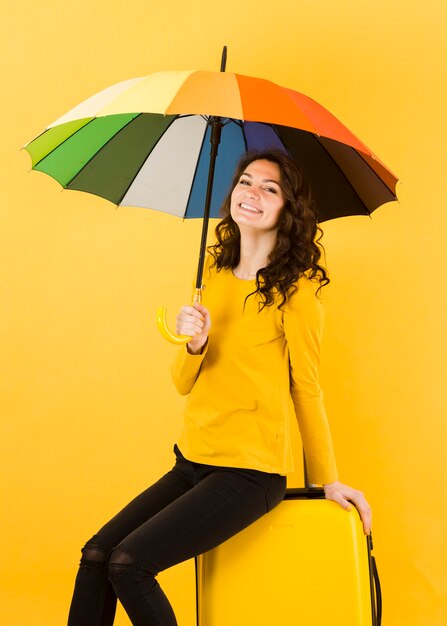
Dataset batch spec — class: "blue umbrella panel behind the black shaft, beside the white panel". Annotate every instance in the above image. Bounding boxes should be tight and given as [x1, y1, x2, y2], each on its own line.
[185, 121, 246, 218]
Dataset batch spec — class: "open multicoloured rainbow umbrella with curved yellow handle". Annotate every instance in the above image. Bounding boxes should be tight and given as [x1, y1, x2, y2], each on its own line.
[25, 49, 397, 343]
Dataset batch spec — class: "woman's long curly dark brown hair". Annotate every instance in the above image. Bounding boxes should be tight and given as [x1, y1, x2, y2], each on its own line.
[208, 149, 330, 309]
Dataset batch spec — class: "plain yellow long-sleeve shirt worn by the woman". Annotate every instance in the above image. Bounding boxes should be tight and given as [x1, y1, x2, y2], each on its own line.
[172, 258, 337, 484]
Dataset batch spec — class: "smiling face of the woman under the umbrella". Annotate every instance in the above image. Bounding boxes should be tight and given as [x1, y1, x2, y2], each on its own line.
[230, 159, 285, 231]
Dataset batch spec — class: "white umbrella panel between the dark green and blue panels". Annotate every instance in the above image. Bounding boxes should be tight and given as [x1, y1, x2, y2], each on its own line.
[121, 115, 209, 217]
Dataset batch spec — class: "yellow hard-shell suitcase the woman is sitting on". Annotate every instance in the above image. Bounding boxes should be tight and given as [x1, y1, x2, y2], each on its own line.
[196, 488, 381, 626]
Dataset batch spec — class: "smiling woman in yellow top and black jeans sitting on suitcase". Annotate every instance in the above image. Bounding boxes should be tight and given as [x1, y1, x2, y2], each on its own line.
[69, 151, 371, 626]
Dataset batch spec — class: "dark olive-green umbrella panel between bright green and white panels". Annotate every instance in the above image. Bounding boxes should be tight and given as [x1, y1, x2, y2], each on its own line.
[67, 115, 175, 205]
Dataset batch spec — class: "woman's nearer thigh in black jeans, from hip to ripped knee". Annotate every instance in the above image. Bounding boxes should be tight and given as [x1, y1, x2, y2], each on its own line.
[118, 468, 286, 574]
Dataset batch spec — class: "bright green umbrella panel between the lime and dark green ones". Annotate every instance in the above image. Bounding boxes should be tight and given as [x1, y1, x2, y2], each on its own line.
[35, 115, 135, 187]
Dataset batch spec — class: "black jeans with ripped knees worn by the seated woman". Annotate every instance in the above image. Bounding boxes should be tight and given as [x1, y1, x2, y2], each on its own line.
[68, 446, 286, 626]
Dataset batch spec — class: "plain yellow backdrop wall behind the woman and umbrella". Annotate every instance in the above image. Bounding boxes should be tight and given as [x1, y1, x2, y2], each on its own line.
[0, 0, 447, 626]
